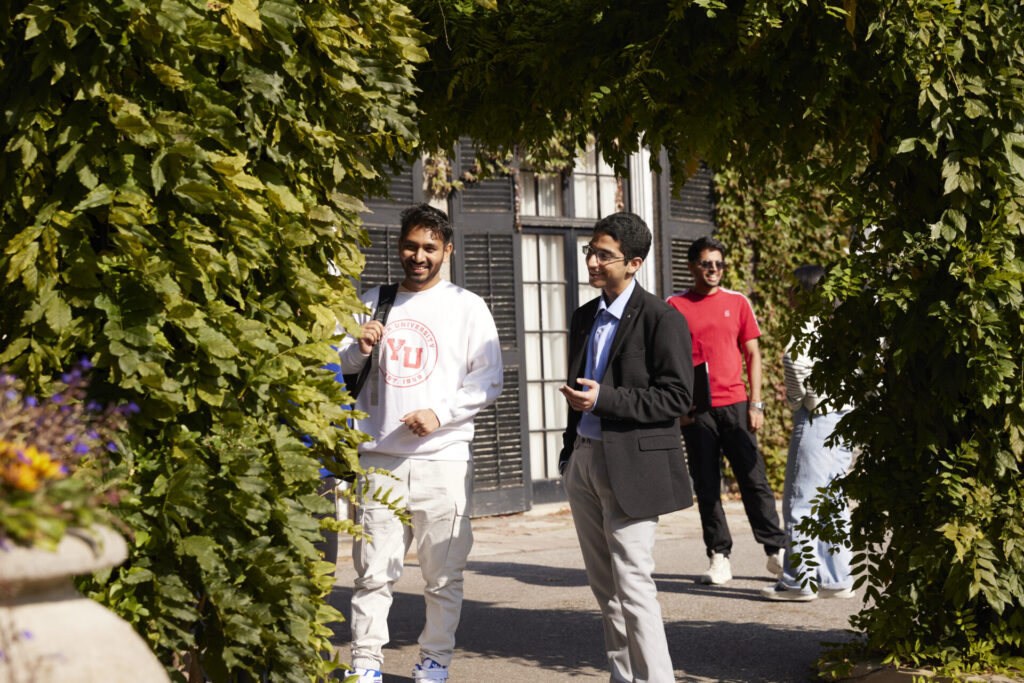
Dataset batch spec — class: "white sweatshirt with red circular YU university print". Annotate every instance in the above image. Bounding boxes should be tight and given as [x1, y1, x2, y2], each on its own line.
[339, 280, 503, 460]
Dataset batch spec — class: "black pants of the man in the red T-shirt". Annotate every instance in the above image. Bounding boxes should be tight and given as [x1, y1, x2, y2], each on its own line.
[683, 400, 785, 557]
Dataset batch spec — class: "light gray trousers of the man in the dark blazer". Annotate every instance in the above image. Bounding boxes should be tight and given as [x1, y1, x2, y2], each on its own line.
[564, 437, 675, 683]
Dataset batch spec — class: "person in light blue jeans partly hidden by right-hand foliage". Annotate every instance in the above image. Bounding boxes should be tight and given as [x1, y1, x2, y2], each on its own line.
[761, 265, 854, 602]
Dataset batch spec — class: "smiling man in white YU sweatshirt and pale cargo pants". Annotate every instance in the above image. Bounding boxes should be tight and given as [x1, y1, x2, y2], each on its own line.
[340, 204, 502, 683]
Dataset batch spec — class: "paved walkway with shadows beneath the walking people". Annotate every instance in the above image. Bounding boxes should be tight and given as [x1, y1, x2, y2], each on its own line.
[332, 502, 860, 683]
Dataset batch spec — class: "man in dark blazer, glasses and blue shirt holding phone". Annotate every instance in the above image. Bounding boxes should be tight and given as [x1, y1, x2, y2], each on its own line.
[559, 213, 693, 683]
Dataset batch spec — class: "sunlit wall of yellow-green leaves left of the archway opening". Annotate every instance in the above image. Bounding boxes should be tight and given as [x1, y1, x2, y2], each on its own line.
[0, 0, 425, 682]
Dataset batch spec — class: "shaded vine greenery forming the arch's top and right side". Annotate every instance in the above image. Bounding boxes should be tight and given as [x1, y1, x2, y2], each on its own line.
[411, 0, 1024, 670]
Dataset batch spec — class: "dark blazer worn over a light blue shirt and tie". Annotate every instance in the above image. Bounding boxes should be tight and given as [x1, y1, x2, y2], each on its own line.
[559, 285, 693, 519]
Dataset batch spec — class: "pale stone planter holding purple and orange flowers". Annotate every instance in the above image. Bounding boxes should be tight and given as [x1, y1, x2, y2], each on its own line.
[0, 526, 169, 683]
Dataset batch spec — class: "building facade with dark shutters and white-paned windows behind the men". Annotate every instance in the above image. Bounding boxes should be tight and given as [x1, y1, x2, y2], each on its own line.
[360, 140, 714, 515]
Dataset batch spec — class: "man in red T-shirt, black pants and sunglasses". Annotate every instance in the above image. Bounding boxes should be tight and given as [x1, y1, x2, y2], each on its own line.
[669, 238, 785, 584]
